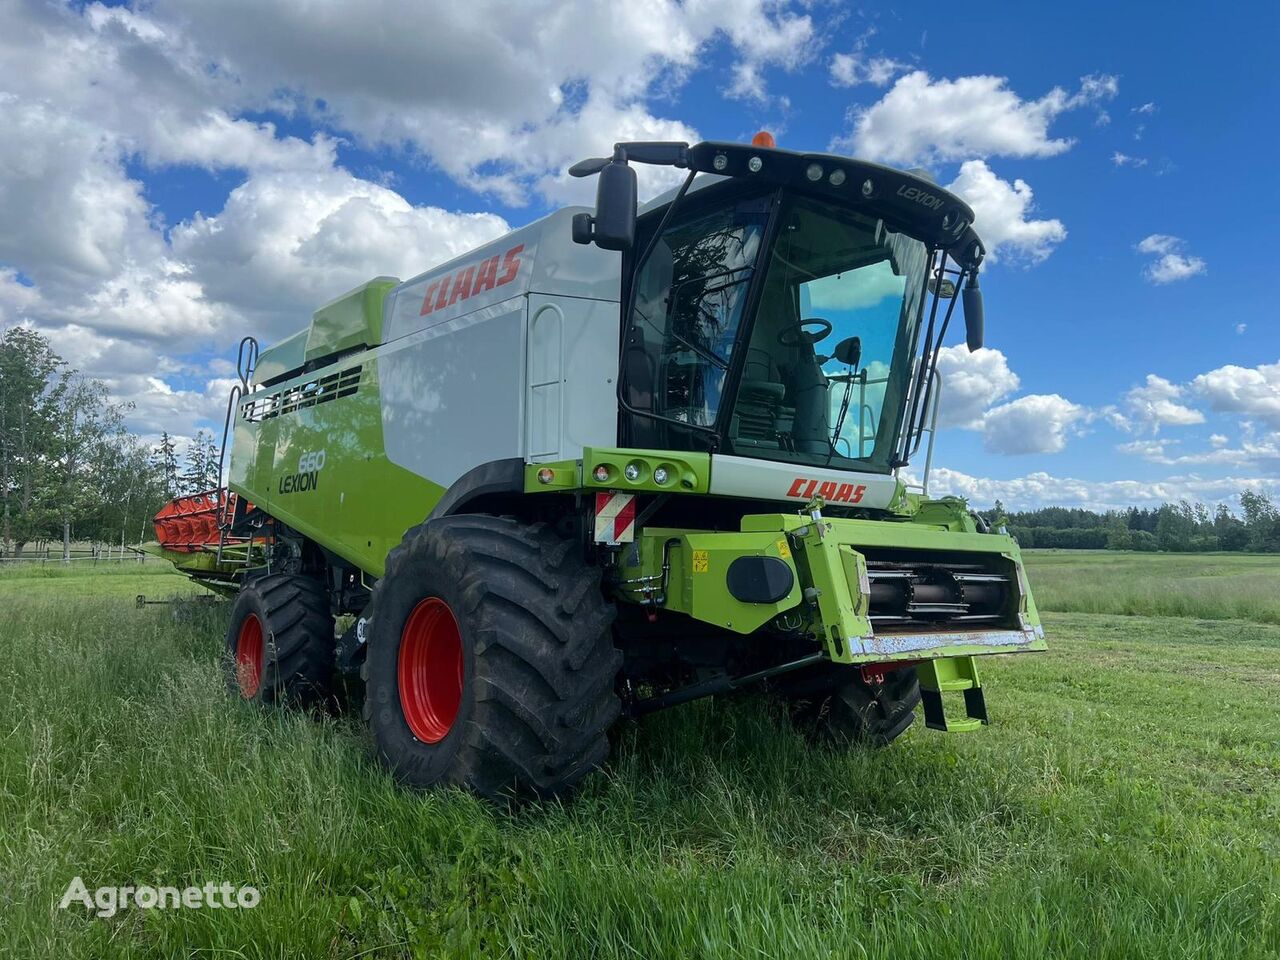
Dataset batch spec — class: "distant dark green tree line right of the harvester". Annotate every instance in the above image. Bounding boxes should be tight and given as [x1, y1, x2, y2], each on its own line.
[979, 490, 1280, 553]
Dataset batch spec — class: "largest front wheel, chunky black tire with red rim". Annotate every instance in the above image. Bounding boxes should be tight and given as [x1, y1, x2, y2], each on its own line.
[362, 515, 622, 799]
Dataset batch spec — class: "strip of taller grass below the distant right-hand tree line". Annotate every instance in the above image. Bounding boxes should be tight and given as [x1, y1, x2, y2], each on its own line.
[1024, 550, 1280, 623]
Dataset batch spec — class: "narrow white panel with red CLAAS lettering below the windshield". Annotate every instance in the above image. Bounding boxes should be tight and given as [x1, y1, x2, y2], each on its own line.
[710, 453, 897, 509]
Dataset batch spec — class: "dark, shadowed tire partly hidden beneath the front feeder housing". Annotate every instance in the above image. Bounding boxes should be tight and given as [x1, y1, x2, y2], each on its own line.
[791, 667, 920, 746]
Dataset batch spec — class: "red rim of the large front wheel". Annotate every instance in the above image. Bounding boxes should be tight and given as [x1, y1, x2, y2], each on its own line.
[396, 596, 462, 744]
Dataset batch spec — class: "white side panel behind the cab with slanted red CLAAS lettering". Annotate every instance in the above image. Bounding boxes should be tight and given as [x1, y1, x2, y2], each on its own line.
[376, 209, 621, 486]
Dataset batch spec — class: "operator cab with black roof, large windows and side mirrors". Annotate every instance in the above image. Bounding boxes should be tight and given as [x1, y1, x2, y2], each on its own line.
[571, 136, 983, 474]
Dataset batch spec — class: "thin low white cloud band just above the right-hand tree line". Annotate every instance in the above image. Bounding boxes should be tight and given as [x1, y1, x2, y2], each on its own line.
[929, 467, 1280, 511]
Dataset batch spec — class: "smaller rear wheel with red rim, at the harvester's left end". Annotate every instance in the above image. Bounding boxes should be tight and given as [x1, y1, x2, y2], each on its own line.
[224, 573, 335, 708]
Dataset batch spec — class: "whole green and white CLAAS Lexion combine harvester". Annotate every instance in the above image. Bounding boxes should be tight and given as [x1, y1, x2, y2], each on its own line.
[156, 134, 1044, 796]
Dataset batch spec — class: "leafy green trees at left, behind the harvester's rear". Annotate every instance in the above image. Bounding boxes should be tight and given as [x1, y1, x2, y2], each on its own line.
[0, 326, 218, 558]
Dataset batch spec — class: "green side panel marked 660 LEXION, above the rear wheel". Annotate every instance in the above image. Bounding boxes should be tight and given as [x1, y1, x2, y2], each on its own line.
[229, 353, 444, 576]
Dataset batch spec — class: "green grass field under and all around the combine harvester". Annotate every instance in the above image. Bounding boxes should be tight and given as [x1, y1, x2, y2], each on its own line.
[0, 553, 1280, 960]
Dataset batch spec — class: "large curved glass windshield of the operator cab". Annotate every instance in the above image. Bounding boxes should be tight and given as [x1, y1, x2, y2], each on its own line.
[622, 195, 928, 472]
